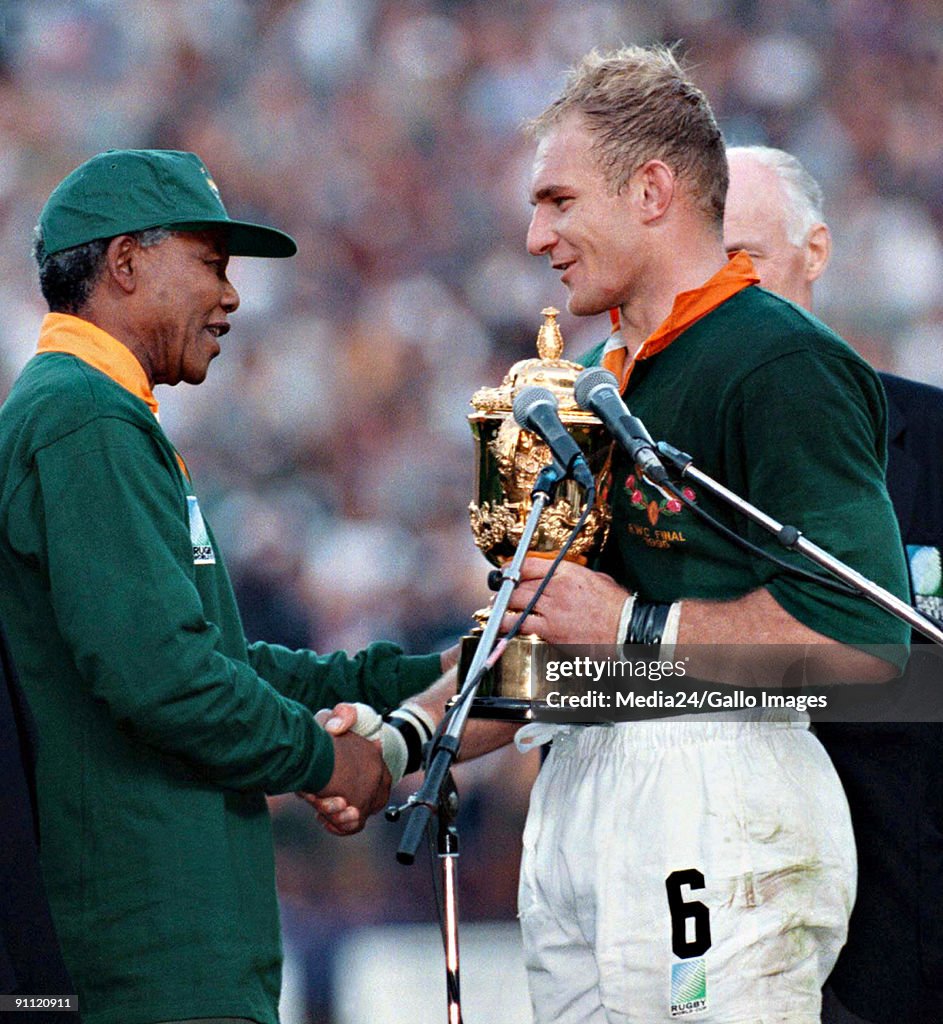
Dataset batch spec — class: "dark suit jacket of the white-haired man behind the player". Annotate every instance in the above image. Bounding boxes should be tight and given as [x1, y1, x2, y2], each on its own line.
[816, 374, 943, 1024]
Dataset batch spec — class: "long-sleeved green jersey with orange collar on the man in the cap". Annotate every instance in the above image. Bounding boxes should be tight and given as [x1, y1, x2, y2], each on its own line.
[0, 314, 439, 1024]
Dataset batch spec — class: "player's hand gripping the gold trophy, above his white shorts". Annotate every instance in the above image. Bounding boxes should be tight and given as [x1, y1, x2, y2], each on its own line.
[501, 558, 629, 644]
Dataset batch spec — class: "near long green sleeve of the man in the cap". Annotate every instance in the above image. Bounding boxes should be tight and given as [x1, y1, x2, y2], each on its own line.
[34, 418, 334, 793]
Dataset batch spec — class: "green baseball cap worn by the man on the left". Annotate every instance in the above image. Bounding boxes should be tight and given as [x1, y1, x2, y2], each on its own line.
[39, 150, 298, 256]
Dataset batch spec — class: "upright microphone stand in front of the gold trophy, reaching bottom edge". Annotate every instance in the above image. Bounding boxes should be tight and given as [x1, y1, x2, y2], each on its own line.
[386, 462, 568, 1024]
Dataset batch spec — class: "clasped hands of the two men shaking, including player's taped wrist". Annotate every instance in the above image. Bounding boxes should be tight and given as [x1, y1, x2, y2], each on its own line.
[299, 703, 435, 836]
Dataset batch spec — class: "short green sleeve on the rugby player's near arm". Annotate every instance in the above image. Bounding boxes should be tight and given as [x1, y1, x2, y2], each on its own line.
[734, 352, 909, 660]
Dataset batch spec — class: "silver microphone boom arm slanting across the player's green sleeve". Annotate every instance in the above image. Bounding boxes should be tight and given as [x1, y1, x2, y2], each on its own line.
[652, 441, 943, 645]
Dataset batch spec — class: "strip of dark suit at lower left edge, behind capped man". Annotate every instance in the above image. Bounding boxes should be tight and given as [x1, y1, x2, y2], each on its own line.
[0, 618, 79, 1024]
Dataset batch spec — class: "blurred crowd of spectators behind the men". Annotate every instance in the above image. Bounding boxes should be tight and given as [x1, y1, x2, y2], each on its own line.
[0, 0, 943, 1022]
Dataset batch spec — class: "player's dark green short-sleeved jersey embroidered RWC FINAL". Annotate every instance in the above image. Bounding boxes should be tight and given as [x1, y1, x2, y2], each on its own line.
[582, 287, 909, 652]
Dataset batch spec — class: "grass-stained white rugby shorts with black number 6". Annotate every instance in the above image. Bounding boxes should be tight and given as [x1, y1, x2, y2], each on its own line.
[519, 720, 857, 1024]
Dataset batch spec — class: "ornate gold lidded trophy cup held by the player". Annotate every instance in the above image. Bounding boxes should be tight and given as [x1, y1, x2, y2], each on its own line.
[459, 307, 612, 722]
